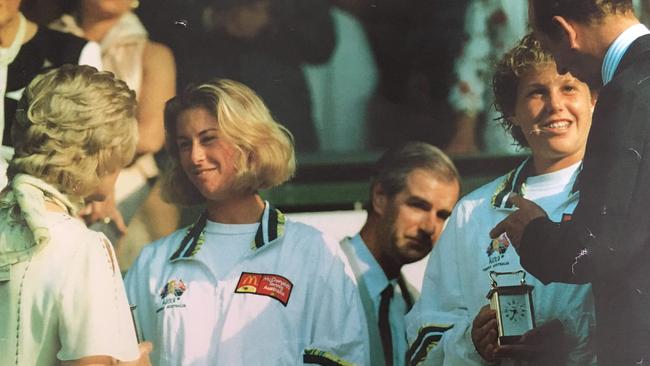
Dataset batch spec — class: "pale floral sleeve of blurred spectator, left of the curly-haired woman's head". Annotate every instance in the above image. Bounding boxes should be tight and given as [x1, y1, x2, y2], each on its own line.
[448, 0, 494, 115]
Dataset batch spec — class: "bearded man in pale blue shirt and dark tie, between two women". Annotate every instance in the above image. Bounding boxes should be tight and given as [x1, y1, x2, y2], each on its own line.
[341, 142, 460, 366]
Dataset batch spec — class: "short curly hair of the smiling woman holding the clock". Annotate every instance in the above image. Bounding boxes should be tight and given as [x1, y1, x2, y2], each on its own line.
[492, 33, 555, 147]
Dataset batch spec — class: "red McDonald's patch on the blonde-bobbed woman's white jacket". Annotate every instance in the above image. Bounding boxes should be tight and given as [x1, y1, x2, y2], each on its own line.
[235, 272, 293, 306]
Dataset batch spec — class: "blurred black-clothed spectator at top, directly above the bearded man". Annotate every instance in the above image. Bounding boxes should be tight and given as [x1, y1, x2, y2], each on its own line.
[330, 0, 467, 150]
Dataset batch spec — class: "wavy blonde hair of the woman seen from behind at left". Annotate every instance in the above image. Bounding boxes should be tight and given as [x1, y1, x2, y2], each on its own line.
[8, 65, 138, 198]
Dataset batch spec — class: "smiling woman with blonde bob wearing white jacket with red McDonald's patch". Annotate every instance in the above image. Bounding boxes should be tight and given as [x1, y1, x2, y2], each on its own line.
[126, 79, 368, 366]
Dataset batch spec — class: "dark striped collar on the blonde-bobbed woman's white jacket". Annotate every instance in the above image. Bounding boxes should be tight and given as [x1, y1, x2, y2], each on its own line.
[169, 201, 285, 262]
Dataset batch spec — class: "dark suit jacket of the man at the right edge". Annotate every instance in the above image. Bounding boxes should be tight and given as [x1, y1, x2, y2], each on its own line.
[519, 35, 650, 365]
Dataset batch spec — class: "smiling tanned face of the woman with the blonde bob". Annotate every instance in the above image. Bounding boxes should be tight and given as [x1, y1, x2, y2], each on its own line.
[176, 107, 239, 202]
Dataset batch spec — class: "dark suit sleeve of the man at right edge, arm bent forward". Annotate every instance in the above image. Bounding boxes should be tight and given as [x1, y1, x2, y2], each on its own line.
[519, 90, 650, 288]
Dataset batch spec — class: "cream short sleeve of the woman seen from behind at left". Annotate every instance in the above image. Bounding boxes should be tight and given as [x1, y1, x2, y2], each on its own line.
[57, 233, 139, 361]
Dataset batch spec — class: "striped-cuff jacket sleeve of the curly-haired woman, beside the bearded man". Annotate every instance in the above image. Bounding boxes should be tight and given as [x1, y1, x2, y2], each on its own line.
[406, 209, 484, 365]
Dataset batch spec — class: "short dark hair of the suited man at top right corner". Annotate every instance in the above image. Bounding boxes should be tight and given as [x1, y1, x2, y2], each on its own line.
[530, 0, 633, 39]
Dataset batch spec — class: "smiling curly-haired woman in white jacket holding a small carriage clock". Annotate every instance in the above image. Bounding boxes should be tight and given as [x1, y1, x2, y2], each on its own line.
[407, 34, 597, 366]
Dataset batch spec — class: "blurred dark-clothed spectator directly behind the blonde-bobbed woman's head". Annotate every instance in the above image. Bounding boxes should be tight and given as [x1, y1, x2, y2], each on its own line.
[173, 0, 336, 152]
